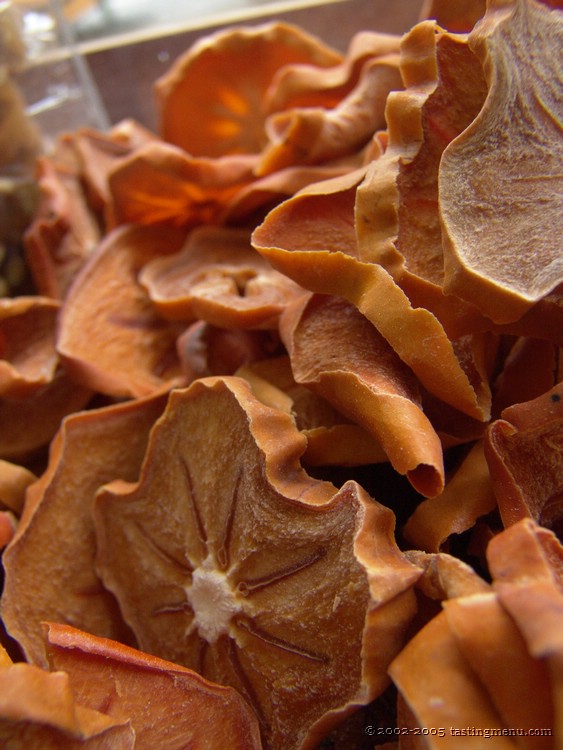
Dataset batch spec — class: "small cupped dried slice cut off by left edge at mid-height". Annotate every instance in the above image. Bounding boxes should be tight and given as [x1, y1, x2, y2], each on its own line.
[0, 296, 60, 397]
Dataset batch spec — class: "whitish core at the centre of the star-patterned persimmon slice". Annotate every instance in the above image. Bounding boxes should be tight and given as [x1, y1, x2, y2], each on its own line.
[186, 555, 242, 643]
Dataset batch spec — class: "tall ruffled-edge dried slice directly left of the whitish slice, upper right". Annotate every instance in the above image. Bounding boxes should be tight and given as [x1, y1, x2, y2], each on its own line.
[356, 21, 486, 337]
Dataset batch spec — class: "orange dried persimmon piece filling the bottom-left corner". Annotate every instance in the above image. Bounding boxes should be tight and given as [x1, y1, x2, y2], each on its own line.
[0, 663, 135, 750]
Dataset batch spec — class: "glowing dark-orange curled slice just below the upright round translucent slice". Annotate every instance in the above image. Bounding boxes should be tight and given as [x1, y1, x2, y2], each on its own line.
[107, 141, 256, 226]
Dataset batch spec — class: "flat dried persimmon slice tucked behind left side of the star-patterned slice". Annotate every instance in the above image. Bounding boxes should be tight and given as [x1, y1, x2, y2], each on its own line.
[1, 396, 166, 665]
